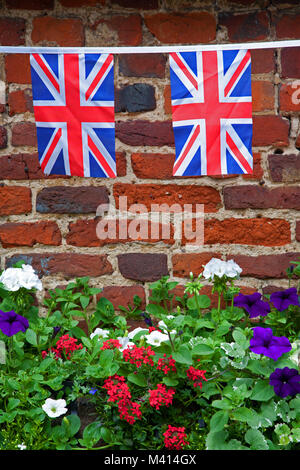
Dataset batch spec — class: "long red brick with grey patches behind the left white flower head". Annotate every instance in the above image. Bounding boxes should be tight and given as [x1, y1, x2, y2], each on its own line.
[6, 253, 113, 278]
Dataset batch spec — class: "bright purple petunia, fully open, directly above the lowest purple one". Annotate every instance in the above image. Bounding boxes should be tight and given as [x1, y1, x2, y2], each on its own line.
[249, 326, 292, 361]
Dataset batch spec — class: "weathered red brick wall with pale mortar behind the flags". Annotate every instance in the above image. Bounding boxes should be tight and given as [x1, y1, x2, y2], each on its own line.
[0, 0, 300, 312]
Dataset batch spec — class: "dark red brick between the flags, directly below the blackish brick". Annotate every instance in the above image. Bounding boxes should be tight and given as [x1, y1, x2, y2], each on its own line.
[116, 120, 175, 147]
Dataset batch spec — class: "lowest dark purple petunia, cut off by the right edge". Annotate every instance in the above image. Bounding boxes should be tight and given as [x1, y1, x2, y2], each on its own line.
[269, 367, 300, 398]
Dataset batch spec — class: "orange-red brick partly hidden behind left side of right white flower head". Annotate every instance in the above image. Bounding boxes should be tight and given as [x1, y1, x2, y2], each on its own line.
[172, 252, 222, 278]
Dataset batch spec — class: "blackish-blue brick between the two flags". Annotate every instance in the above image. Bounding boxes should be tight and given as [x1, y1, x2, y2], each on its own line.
[115, 83, 156, 113]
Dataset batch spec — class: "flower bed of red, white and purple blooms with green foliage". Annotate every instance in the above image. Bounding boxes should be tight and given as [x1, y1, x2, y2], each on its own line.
[0, 259, 300, 450]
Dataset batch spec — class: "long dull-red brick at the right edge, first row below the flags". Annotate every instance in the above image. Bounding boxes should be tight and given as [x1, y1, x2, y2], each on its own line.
[224, 185, 300, 210]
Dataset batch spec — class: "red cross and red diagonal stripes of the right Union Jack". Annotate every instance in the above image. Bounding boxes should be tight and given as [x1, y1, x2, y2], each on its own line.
[171, 51, 252, 175]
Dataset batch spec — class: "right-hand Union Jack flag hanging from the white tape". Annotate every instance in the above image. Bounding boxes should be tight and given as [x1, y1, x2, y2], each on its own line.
[169, 50, 253, 176]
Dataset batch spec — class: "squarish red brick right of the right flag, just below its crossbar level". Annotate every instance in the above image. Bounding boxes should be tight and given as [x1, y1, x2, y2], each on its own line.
[252, 115, 289, 147]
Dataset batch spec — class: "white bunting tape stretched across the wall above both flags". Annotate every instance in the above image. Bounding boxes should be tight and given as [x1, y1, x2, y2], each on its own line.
[0, 39, 300, 54]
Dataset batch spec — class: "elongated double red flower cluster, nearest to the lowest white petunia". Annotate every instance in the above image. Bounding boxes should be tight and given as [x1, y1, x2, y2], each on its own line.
[103, 374, 142, 424]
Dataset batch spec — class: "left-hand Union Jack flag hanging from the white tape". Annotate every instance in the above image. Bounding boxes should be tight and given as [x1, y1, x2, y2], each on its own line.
[30, 54, 116, 178]
